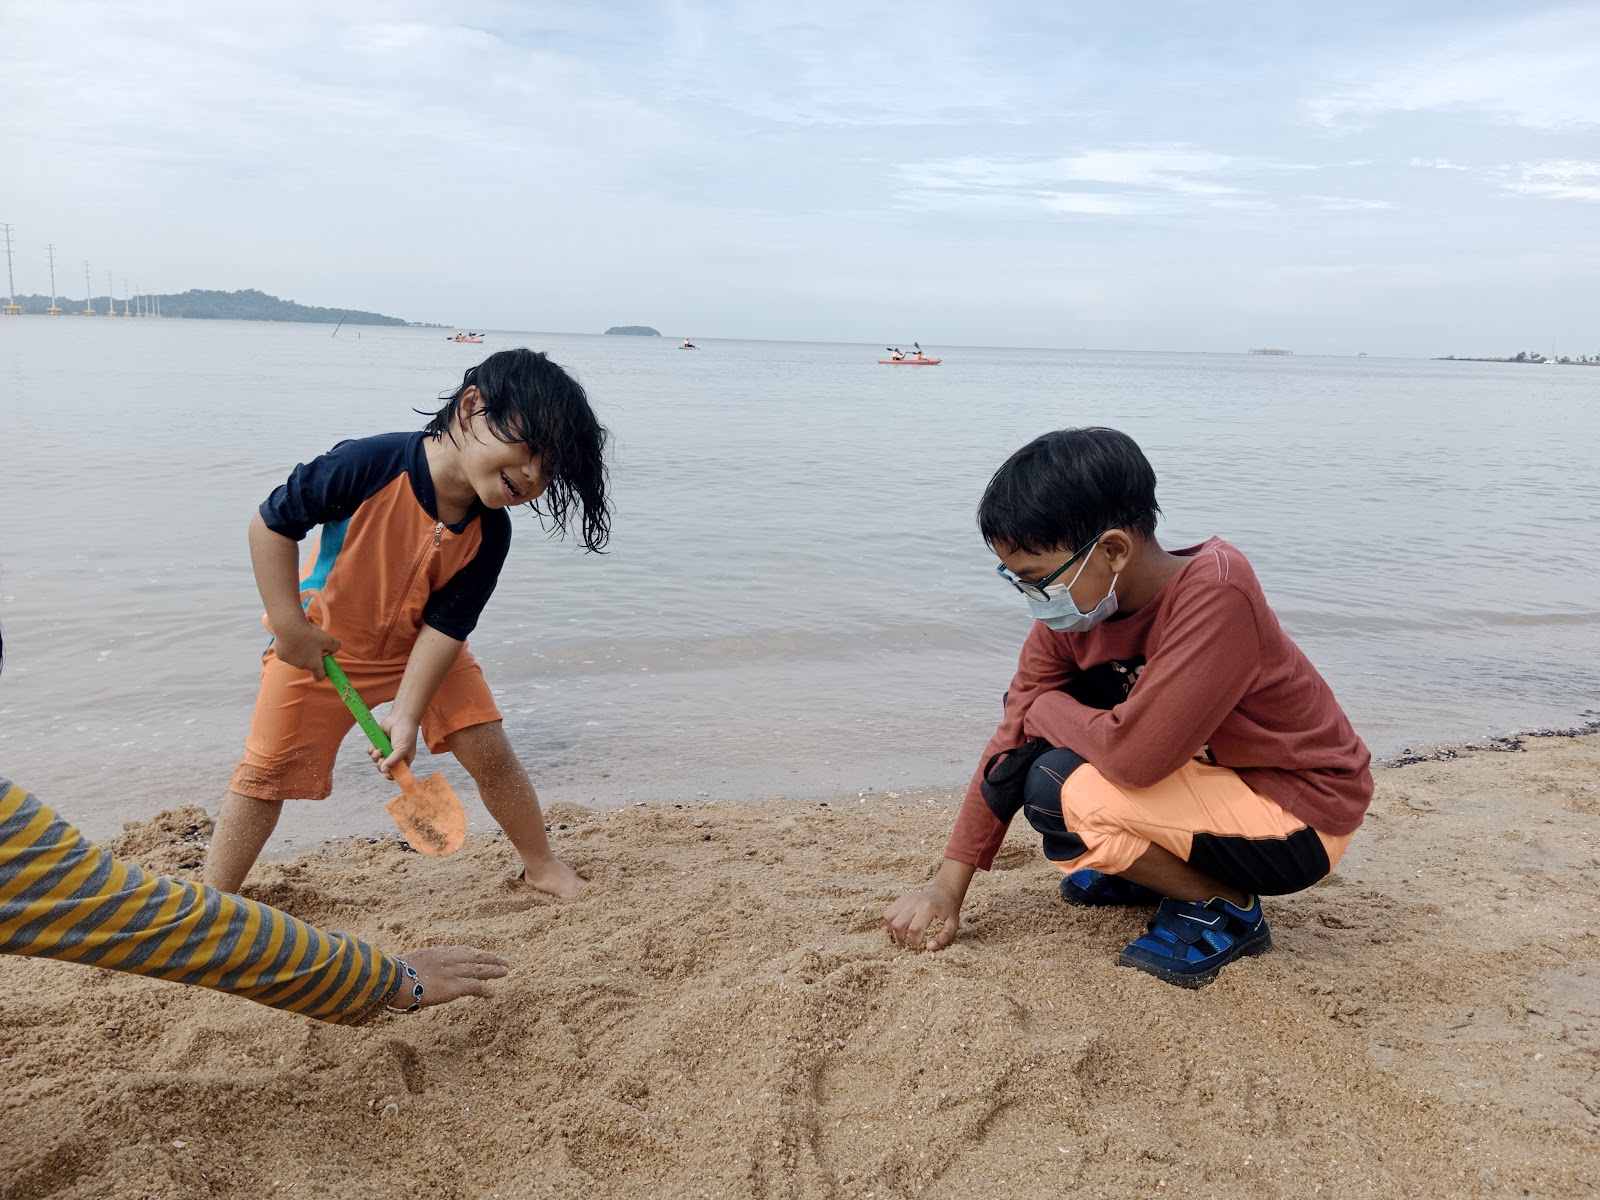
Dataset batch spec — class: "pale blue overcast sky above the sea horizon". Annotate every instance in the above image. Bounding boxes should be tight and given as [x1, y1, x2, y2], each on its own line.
[0, 0, 1600, 355]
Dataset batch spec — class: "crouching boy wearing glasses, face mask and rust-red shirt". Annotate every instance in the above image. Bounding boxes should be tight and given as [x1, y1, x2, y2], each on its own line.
[885, 429, 1373, 987]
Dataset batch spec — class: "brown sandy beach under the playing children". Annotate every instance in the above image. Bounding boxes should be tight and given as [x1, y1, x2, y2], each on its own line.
[0, 734, 1600, 1200]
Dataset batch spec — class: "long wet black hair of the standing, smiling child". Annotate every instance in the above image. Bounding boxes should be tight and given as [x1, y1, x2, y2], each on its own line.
[418, 347, 611, 554]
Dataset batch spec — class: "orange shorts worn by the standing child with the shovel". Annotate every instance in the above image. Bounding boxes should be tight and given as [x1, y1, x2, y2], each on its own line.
[229, 646, 501, 800]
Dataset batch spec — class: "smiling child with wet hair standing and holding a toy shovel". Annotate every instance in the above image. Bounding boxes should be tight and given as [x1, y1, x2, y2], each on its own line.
[205, 349, 611, 898]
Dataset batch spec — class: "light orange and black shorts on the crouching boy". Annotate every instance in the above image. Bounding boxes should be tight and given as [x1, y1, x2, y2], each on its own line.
[1035, 758, 1352, 894]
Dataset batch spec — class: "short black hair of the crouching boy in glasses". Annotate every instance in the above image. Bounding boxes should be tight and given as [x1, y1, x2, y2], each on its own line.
[978, 426, 1162, 554]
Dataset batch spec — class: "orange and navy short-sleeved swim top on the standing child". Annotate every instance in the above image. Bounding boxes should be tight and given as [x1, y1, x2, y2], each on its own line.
[261, 434, 510, 662]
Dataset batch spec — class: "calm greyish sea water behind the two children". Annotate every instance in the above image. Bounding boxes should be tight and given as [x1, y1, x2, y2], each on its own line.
[0, 318, 1600, 848]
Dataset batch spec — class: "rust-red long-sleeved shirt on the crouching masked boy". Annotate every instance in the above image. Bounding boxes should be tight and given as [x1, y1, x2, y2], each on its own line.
[944, 538, 1373, 870]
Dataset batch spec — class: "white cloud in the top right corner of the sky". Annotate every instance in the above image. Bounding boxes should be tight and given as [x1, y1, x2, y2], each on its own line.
[1310, 6, 1600, 130]
